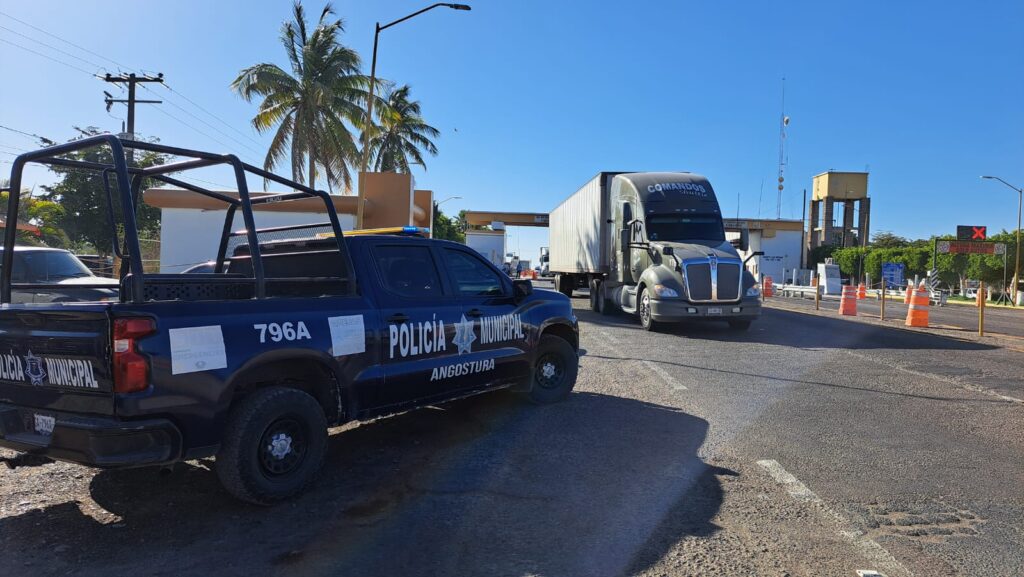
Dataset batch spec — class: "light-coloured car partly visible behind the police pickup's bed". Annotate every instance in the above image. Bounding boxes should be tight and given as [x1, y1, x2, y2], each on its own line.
[0, 246, 118, 303]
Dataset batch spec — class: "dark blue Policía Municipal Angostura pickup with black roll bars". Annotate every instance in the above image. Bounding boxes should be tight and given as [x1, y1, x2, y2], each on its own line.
[0, 136, 579, 503]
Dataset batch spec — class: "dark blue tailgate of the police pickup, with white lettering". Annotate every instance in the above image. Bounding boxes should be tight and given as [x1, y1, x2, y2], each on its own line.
[0, 303, 114, 415]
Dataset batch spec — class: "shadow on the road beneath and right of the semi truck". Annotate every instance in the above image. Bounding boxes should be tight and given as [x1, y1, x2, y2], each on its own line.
[575, 308, 998, 351]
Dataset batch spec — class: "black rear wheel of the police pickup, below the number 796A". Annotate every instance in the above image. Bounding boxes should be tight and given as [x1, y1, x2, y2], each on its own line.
[215, 386, 327, 505]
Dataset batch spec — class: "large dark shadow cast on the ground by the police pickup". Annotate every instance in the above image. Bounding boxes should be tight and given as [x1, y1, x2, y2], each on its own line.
[0, 393, 724, 576]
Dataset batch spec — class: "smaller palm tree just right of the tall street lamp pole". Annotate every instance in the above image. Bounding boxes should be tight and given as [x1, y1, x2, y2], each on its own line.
[370, 84, 440, 172]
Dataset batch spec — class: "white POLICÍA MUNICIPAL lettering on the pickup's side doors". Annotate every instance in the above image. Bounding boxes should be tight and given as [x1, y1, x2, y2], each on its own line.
[388, 313, 526, 359]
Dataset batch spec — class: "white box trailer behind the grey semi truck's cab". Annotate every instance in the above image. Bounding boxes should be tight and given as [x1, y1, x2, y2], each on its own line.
[548, 172, 621, 275]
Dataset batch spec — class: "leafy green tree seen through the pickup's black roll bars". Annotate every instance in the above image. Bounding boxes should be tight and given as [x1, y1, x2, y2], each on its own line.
[40, 126, 167, 254]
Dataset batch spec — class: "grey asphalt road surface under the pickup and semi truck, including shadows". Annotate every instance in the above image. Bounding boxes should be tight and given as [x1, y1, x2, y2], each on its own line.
[0, 291, 1024, 577]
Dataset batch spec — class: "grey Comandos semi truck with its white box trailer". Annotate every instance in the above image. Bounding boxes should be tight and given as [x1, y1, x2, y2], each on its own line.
[549, 172, 761, 330]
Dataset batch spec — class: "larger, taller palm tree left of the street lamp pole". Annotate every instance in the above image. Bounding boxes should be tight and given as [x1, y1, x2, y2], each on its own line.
[231, 0, 369, 190]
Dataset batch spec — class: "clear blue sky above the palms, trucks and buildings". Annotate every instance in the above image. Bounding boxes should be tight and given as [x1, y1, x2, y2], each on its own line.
[0, 0, 1024, 259]
